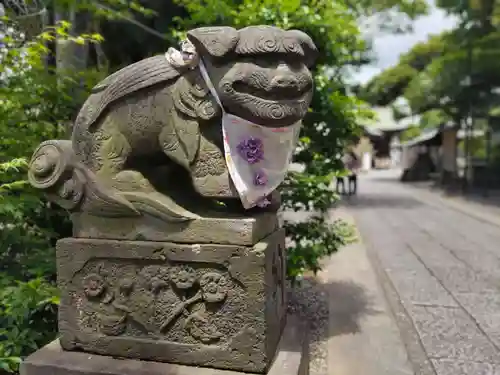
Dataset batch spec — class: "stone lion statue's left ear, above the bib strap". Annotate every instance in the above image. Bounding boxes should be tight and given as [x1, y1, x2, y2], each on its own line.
[187, 26, 239, 58]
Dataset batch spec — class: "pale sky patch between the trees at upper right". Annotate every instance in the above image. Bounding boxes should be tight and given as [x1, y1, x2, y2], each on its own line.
[354, 1, 456, 83]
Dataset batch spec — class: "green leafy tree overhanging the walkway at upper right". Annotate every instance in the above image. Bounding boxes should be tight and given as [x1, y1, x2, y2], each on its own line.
[361, 0, 500, 131]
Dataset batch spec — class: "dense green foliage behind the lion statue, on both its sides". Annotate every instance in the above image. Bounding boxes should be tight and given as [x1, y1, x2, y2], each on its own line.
[0, 0, 425, 372]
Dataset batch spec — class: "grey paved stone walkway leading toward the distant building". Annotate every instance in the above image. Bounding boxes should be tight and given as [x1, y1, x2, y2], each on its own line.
[347, 172, 500, 375]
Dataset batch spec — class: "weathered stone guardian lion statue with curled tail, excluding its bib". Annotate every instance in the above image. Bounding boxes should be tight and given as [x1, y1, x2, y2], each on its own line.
[29, 26, 317, 221]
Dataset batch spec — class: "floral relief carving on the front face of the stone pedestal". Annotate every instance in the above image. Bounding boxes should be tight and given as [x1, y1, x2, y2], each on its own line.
[73, 261, 242, 345]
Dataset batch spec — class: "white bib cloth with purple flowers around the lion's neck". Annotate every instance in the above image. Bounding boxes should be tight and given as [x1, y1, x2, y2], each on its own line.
[199, 59, 301, 209]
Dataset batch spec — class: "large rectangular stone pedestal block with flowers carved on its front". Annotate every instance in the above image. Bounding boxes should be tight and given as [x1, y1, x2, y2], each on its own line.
[19, 223, 301, 375]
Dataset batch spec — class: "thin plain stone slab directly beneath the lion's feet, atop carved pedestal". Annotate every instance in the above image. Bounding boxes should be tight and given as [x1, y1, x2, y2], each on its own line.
[71, 213, 281, 246]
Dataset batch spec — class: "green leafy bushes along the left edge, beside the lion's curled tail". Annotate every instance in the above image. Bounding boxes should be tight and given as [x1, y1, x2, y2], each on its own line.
[0, 19, 104, 371]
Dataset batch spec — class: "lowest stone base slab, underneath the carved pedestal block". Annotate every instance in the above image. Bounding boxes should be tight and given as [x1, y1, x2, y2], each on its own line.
[21, 316, 309, 375]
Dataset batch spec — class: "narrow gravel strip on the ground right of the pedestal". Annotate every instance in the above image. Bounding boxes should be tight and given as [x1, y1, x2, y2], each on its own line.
[288, 277, 329, 375]
